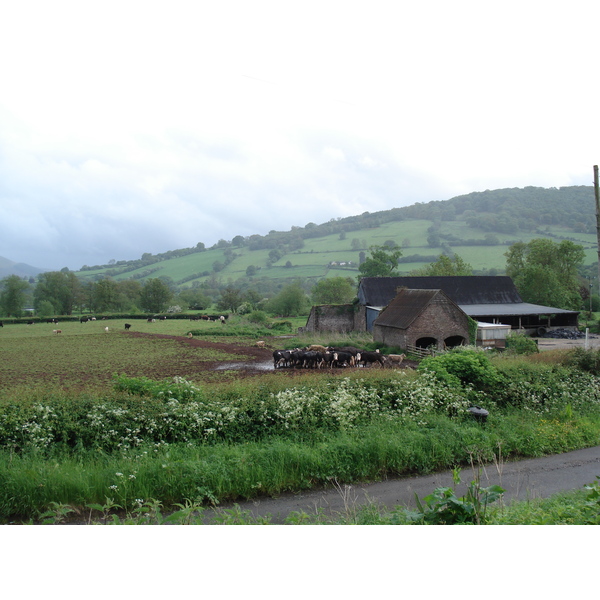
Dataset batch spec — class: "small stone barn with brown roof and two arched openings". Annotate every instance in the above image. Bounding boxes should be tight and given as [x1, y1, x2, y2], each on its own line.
[373, 288, 469, 348]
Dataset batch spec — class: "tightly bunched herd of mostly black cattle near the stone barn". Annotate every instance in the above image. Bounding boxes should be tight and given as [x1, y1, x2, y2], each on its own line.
[273, 344, 405, 369]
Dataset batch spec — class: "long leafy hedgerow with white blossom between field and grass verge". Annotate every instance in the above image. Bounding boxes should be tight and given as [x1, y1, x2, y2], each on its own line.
[0, 352, 600, 452]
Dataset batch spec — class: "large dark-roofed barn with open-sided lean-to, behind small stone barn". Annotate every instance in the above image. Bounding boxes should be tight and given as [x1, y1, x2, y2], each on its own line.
[358, 275, 579, 335]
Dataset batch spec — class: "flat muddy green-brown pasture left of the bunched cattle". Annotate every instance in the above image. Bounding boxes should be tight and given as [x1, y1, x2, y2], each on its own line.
[0, 320, 415, 391]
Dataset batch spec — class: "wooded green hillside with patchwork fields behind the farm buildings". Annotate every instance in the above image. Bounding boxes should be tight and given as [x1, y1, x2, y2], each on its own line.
[77, 186, 597, 289]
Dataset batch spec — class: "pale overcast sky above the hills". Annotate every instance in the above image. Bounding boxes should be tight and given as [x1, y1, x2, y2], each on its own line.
[0, 0, 600, 269]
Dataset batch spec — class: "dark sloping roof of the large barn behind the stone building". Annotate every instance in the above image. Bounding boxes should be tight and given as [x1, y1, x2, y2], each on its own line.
[358, 275, 523, 306]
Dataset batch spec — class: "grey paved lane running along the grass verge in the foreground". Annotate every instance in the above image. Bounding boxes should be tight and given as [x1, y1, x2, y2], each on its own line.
[206, 446, 600, 523]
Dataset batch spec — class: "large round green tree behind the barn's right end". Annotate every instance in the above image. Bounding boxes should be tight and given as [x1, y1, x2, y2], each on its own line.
[505, 238, 585, 310]
